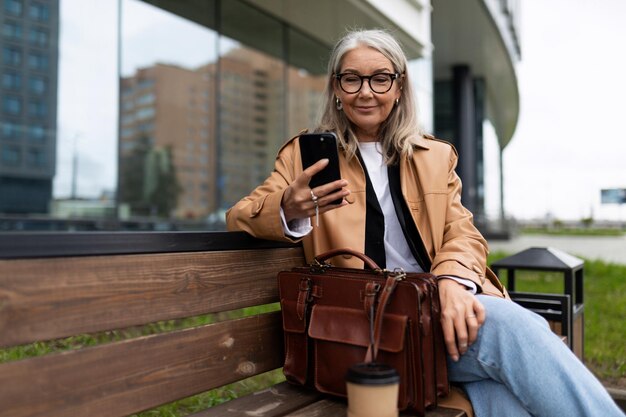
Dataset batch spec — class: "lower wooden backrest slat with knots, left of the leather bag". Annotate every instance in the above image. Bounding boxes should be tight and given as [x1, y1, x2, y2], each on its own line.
[0, 312, 283, 417]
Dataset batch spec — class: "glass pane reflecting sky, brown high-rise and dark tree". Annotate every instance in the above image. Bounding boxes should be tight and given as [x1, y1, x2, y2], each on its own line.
[119, 0, 217, 219]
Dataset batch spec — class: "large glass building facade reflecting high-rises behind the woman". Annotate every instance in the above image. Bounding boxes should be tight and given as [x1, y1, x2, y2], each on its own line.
[0, 0, 517, 231]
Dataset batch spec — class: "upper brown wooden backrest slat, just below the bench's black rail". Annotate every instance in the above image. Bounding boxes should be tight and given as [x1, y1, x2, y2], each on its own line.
[0, 247, 304, 347]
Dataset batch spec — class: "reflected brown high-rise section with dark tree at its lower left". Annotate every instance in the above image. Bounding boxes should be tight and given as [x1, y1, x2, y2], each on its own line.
[119, 64, 216, 218]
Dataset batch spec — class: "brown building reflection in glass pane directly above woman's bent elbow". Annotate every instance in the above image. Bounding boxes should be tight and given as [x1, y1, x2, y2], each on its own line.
[218, 37, 285, 209]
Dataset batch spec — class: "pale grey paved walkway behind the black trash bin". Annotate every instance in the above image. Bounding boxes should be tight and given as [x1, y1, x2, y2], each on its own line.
[489, 235, 626, 265]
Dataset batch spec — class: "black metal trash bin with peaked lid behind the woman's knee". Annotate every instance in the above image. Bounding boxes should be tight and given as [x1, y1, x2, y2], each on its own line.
[491, 248, 585, 360]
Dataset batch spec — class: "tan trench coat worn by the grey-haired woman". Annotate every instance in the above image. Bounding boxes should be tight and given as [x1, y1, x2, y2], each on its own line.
[226, 133, 508, 408]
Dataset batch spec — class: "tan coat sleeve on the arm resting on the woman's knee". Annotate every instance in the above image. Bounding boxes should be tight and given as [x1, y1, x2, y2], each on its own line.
[431, 147, 488, 292]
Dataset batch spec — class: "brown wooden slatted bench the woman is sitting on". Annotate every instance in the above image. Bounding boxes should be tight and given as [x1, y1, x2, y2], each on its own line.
[0, 232, 464, 417]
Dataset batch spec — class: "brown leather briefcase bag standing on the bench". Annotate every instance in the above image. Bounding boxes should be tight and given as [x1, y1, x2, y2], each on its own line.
[278, 249, 449, 415]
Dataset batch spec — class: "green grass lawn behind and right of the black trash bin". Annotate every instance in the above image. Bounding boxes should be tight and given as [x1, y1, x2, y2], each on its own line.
[488, 252, 626, 386]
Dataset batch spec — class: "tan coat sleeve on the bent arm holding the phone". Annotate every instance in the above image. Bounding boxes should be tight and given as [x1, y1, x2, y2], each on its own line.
[226, 140, 297, 242]
